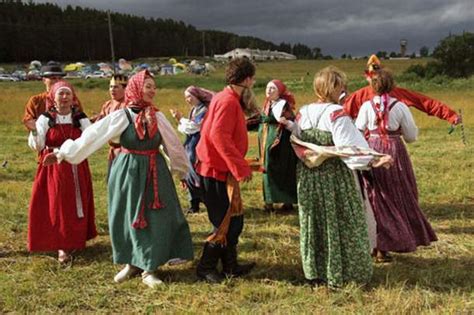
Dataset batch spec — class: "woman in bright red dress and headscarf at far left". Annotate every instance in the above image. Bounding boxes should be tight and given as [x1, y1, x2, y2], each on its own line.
[28, 81, 97, 263]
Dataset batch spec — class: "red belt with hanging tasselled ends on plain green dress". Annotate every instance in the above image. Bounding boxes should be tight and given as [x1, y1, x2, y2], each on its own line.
[120, 147, 163, 229]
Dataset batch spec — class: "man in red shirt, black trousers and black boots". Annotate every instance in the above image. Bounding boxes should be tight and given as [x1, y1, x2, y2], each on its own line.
[196, 58, 255, 283]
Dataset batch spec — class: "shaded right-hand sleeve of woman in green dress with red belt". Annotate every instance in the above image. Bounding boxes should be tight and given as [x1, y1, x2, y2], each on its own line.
[156, 112, 191, 179]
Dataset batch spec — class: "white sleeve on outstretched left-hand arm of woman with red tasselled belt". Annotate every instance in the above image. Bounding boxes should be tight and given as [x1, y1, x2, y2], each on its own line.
[54, 109, 129, 164]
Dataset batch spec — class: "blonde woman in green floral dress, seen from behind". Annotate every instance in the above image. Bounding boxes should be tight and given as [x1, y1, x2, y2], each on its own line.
[288, 67, 392, 287]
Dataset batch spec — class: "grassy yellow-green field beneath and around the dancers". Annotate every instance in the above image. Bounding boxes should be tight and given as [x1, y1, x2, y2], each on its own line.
[0, 60, 474, 314]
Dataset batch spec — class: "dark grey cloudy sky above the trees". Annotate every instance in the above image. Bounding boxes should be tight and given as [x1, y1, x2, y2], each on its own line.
[35, 0, 474, 57]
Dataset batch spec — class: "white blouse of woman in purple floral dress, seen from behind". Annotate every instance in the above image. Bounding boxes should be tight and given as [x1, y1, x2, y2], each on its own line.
[355, 95, 418, 142]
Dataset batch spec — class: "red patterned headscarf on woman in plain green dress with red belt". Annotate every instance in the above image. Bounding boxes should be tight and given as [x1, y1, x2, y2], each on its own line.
[125, 70, 158, 140]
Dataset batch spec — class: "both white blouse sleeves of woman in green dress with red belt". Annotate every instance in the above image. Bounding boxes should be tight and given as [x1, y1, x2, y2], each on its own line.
[54, 109, 191, 178]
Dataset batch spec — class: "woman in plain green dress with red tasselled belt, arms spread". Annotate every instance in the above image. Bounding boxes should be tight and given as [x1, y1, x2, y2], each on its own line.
[46, 70, 193, 288]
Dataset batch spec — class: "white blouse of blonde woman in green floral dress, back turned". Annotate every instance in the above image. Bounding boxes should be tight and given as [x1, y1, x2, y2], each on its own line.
[292, 103, 373, 170]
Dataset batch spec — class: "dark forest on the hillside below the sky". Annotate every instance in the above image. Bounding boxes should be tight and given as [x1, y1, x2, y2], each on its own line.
[0, 0, 323, 62]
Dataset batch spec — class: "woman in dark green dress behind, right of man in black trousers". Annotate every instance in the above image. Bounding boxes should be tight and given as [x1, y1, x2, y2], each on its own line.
[258, 80, 298, 211]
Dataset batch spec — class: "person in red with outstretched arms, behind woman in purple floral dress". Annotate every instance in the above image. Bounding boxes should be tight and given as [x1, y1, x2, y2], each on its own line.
[344, 55, 461, 125]
